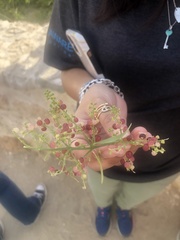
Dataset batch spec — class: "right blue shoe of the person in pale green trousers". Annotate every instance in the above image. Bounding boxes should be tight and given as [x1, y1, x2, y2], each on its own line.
[116, 207, 133, 237]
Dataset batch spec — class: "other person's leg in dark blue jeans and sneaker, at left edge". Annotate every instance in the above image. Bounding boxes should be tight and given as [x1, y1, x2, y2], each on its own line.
[0, 171, 47, 240]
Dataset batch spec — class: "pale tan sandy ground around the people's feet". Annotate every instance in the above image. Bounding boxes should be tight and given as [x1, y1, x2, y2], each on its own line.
[0, 21, 180, 240]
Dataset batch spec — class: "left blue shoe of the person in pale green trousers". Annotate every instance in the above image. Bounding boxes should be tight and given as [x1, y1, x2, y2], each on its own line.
[95, 207, 111, 236]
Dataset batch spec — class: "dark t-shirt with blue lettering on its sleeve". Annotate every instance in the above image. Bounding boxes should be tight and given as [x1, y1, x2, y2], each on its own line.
[44, 0, 180, 182]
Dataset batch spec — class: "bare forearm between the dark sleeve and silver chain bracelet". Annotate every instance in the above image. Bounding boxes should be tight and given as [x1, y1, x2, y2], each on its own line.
[61, 68, 93, 101]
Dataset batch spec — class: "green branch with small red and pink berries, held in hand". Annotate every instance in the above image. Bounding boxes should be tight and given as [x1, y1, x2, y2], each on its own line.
[13, 90, 166, 188]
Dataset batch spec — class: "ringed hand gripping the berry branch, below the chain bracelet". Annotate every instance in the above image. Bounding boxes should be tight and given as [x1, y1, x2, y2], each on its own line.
[75, 84, 151, 171]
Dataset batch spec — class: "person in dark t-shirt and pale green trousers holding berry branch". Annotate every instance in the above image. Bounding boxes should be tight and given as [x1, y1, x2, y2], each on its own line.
[44, 0, 180, 236]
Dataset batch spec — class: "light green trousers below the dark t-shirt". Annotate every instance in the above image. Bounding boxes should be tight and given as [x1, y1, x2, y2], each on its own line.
[88, 168, 179, 210]
